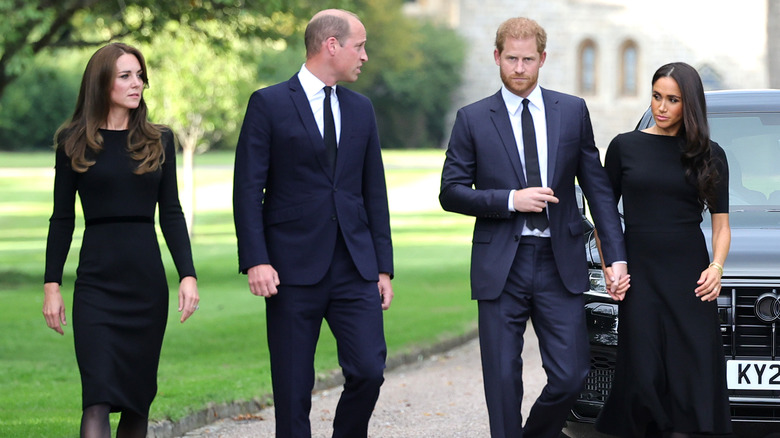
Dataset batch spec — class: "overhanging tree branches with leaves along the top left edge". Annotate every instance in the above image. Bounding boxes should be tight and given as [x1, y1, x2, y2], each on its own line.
[0, 0, 317, 96]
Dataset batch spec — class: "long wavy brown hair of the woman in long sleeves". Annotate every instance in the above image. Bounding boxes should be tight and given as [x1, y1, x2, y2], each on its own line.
[54, 43, 165, 174]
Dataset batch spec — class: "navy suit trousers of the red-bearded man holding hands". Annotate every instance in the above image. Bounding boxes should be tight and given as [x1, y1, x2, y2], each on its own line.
[478, 237, 590, 438]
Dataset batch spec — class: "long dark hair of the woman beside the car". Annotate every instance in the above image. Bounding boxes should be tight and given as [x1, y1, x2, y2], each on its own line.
[653, 62, 719, 207]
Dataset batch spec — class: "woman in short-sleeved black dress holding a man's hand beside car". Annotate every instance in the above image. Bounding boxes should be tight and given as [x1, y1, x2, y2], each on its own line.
[596, 63, 731, 437]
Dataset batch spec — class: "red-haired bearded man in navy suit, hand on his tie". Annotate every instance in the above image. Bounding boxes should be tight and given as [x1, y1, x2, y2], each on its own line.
[439, 18, 628, 438]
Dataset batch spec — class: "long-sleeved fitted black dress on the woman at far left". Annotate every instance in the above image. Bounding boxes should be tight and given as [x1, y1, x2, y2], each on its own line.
[45, 130, 195, 417]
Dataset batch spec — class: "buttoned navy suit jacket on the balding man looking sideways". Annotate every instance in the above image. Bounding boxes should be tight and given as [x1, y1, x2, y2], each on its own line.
[233, 74, 393, 285]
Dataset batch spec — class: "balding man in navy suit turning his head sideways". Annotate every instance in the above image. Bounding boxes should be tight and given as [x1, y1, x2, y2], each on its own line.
[233, 10, 393, 438]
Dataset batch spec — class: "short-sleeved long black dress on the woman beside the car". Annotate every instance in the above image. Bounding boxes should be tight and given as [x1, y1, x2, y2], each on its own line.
[596, 131, 731, 437]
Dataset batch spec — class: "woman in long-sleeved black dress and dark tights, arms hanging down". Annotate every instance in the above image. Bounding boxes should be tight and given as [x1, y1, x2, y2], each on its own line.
[43, 43, 199, 438]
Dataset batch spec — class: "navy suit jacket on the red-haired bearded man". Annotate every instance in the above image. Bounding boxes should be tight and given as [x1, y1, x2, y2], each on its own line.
[439, 89, 626, 300]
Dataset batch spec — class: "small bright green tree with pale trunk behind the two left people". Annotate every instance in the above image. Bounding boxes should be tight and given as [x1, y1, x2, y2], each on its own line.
[142, 23, 254, 231]
